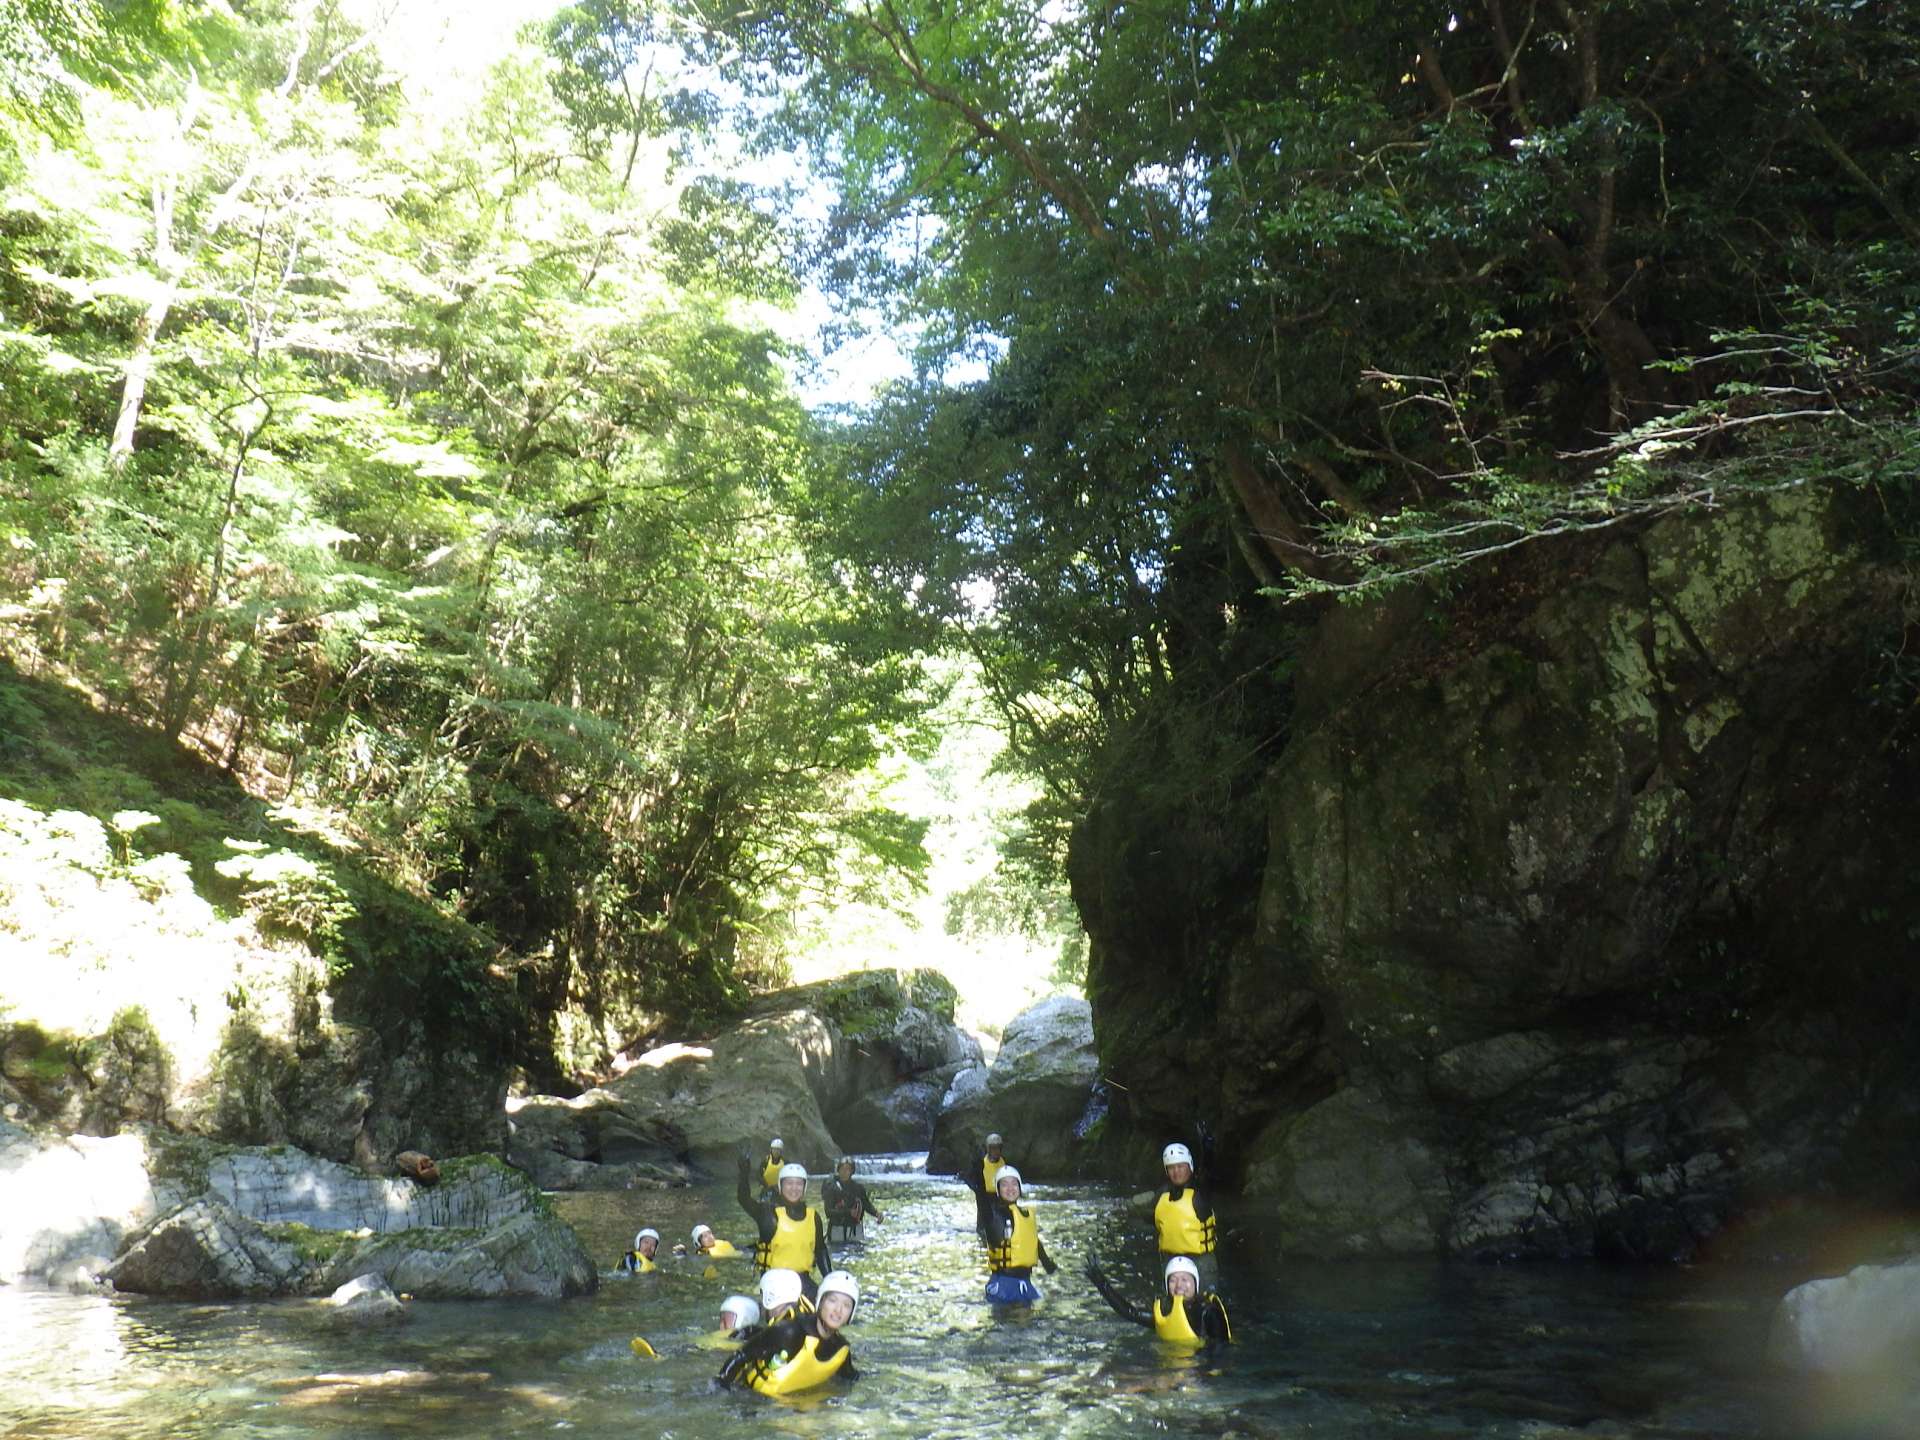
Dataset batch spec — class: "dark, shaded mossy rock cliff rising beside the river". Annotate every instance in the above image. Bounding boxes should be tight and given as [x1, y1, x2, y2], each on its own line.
[1073, 486, 1920, 1256]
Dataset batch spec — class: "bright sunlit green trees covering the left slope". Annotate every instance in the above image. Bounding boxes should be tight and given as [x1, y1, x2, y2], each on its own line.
[0, 0, 940, 1075]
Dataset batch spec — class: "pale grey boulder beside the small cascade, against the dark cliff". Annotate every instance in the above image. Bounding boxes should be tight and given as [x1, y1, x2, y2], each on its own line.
[927, 995, 1100, 1179]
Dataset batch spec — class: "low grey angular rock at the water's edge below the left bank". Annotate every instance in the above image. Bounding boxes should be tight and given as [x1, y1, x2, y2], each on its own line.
[106, 1144, 583, 1300]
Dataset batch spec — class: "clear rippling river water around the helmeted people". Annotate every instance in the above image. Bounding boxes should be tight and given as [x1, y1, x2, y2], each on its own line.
[0, 1156, 1916, 1440]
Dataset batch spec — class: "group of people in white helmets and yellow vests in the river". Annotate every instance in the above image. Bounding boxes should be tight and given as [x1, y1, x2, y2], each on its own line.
[620, 1125, 1233, 1396]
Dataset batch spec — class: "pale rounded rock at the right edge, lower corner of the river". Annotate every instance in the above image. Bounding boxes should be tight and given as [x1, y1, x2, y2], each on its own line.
[1766, 1258, 1920, 1396]
